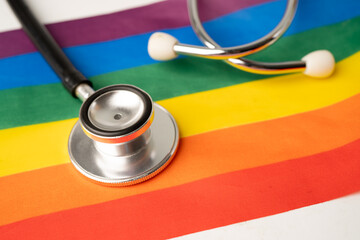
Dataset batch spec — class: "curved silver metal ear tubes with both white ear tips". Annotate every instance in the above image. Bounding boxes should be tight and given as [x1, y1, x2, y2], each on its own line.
[148, 0, 335, 78]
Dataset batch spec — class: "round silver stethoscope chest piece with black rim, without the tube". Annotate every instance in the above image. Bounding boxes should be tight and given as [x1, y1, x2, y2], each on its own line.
[68, 85, 179, 185]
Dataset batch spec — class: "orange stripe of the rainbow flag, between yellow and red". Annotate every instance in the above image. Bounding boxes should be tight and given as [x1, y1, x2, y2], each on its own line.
[0, 95, 360, 225]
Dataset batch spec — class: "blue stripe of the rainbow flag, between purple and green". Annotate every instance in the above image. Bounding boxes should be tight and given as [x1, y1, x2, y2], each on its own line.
[0, 0, 360, 89]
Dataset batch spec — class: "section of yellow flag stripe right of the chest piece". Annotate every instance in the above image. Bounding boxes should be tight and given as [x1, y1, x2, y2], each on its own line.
[158, 52, 360, 137]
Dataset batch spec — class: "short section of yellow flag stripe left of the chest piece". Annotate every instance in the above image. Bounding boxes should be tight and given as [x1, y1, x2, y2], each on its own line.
[0, 119, 76, 177]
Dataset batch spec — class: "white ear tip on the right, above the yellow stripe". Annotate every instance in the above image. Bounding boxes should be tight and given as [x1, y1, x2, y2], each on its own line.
[301, 50, 335, 78]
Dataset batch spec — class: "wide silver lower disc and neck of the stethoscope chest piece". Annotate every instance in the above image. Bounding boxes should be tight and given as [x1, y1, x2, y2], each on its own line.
[68, 103, 179, 185]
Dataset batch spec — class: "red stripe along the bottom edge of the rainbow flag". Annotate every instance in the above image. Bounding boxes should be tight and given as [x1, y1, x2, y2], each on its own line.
[0, 140, 360, 239]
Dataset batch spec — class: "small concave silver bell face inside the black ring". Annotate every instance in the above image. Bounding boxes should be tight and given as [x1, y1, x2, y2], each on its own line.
[88, 90, 145, 131]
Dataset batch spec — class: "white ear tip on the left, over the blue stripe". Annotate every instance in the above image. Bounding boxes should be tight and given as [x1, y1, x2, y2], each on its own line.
[148, 32, 178, 61]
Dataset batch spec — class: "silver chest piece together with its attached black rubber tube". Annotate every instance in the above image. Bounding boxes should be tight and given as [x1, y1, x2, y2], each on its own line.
[7, 0, 179, 186]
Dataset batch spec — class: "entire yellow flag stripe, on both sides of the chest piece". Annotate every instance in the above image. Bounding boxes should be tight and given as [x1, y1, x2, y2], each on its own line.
[0, 53, 360, 176]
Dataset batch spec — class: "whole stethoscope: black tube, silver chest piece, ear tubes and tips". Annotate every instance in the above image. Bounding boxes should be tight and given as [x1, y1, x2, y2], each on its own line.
[7, 0, 335, 186]
